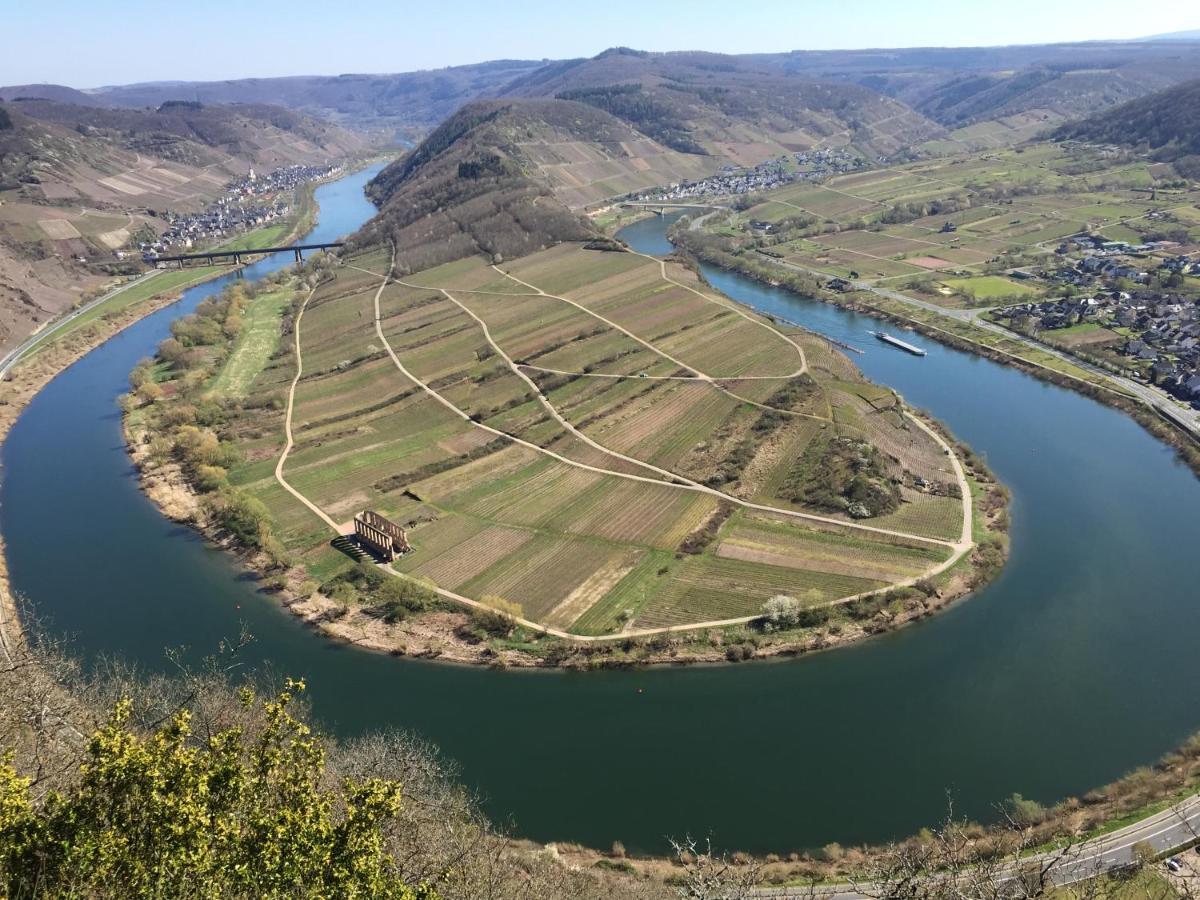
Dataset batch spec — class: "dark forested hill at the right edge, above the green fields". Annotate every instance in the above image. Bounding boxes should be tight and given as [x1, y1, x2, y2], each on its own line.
[1055, 79, 1200, 168]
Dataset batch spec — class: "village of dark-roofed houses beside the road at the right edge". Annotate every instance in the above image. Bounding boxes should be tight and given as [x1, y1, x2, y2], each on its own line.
[989, 234, 1200, 409]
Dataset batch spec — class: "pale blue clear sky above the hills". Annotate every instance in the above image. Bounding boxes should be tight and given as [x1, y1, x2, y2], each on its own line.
[0, 0, 1200, 88]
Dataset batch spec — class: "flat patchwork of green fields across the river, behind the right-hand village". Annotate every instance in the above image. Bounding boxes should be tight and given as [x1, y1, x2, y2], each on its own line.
[708, 142, 1200, 310]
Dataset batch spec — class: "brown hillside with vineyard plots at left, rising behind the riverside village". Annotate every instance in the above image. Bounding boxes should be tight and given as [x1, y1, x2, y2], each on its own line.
[0, 98, 370, 352]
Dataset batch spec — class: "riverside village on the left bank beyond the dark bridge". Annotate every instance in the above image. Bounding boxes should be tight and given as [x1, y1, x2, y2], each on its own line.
[140, 166, 342, 260]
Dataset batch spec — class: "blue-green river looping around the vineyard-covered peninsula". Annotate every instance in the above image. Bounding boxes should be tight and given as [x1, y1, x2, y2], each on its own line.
[0, 181, 1200, 852]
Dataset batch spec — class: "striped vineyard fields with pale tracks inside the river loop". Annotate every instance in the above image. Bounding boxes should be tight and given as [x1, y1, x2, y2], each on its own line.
[223, 244, 970, 636]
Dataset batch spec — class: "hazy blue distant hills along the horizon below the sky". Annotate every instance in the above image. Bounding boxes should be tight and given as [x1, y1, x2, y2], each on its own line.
[18, 32, 1200, 136]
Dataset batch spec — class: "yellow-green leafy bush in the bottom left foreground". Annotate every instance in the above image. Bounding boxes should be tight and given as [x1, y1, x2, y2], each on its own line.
[0, 682, 437, 900]
